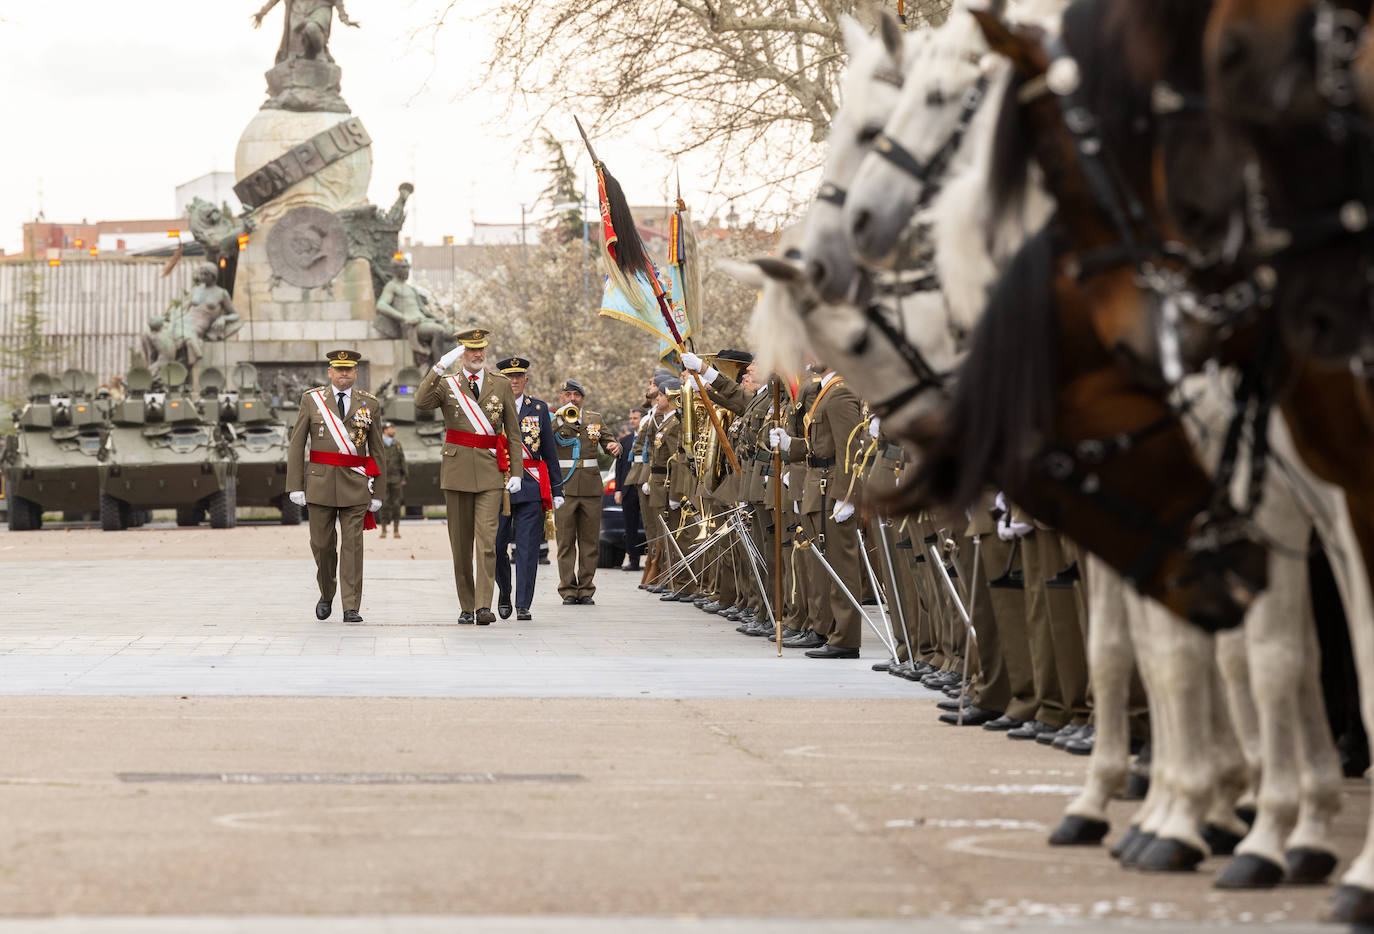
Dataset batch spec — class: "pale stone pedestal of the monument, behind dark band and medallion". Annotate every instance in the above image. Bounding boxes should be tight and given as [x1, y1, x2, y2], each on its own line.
[205, 110, 409, 389]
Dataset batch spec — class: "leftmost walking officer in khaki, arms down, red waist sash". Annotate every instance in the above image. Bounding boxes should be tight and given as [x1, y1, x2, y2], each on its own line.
[286, 350, 386, 622]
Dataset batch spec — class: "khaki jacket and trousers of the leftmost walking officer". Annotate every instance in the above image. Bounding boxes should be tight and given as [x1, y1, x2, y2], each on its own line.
[286, 386, 386, 611]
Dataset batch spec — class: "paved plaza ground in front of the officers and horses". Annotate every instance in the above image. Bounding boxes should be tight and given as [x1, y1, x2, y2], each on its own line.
[0, 522, 1369, 934]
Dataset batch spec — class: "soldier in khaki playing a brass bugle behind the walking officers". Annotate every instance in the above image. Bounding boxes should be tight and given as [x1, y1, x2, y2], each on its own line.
[554, 379, 620, 606]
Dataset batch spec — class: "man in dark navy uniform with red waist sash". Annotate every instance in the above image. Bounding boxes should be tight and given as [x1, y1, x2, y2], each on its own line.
[496, 357, 563, 619]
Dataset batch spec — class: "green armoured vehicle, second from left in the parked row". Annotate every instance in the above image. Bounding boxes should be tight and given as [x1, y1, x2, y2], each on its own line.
[100, 363, 236, 532]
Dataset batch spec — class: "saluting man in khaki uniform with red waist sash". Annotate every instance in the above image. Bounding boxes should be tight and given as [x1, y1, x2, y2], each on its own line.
[415, 327, 525, 626]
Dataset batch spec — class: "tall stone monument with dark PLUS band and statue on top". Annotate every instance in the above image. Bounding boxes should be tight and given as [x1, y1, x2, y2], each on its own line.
[190, 0, 428, 386]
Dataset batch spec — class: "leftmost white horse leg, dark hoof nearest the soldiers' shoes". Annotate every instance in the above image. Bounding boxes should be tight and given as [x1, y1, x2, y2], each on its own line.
[1050, 552, 1135, 846]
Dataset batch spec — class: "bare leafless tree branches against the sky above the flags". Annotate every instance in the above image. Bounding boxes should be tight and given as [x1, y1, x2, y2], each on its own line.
[423, 0, 949, 204]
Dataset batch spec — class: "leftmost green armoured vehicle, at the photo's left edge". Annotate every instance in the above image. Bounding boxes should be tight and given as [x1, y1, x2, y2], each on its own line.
[0, 369, 109, 532]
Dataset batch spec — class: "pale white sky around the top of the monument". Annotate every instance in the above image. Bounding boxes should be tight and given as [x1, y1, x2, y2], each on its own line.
[0, 0, 725, 251]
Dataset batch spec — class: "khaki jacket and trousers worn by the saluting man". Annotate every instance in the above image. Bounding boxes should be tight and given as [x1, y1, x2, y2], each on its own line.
[415, 367, 523, 613]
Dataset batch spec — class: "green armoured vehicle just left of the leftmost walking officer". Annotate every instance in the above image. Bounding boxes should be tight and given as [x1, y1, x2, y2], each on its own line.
[211, 363, 301, 525]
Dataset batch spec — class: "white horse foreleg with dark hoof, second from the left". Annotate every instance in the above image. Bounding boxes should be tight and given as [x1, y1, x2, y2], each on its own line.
[1135, 603, 1216, 872]
